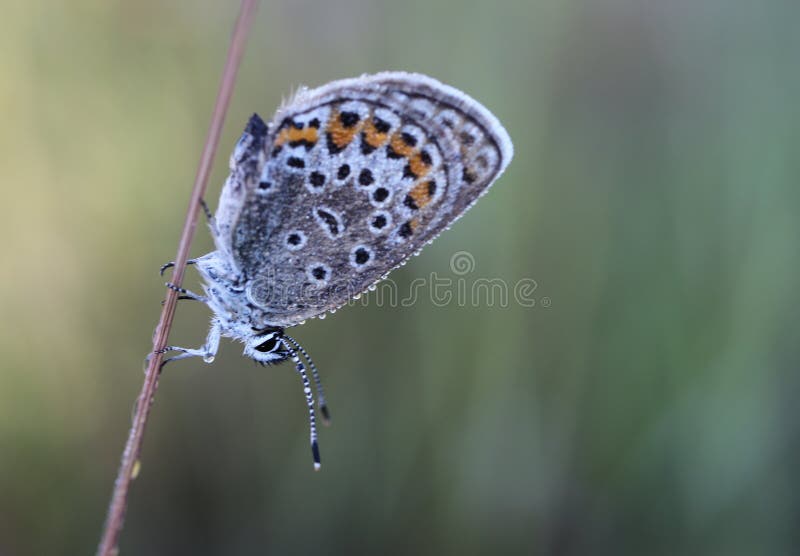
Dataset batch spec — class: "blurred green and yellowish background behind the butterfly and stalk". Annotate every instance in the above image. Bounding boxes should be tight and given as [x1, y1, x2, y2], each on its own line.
[0, 0, 800, 556]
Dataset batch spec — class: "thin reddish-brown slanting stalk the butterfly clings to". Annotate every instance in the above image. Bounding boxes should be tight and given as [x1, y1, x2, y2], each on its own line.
[97, 0, 258, 556]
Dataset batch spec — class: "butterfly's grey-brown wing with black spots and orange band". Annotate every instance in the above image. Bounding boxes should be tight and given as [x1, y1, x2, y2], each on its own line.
[217, 72, 513, 326]
